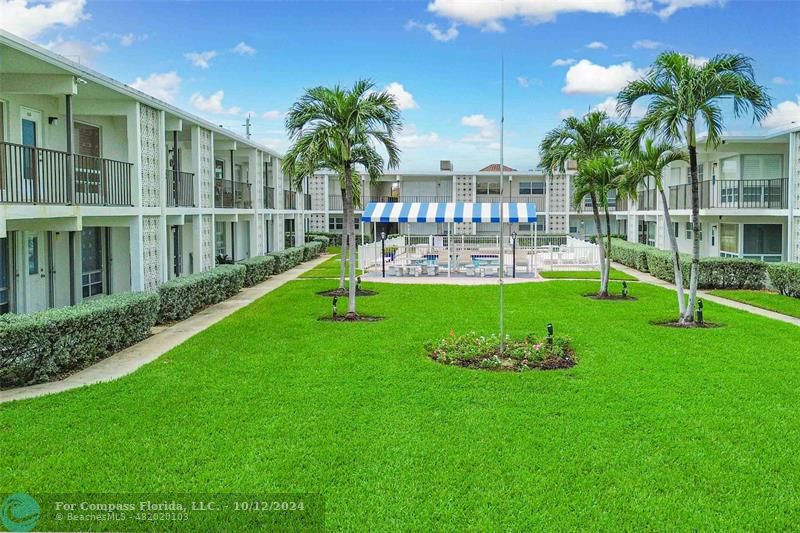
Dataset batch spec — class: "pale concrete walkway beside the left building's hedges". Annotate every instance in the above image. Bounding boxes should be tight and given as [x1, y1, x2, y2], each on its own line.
[0, 254, 331, 403]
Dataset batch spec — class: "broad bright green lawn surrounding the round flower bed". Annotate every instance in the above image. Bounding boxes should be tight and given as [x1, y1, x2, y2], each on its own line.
[0, 280, 800, 531]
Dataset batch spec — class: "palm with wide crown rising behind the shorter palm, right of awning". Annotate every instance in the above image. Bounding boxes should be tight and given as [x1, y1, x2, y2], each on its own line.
[539, 111, 627, 296]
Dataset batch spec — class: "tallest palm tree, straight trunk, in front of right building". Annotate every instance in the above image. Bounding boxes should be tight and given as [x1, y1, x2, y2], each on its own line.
[617, 52, 772, 323]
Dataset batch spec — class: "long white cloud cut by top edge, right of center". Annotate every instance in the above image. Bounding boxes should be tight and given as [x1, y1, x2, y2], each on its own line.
[428, 0, 724, 31]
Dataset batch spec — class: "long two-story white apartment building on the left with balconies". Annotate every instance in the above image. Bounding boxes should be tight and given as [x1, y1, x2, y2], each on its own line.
[0, 32, 310, 313]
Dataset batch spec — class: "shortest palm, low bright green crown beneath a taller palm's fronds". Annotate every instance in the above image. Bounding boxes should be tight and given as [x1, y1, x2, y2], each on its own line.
[572, 152, 625, 297]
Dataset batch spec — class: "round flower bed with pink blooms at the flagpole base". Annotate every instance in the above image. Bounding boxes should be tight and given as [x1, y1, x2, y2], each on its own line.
[425, 331, 577, 371]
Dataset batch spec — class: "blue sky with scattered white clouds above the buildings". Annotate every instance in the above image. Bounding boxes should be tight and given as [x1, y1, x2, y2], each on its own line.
[6, 0, 800, 171]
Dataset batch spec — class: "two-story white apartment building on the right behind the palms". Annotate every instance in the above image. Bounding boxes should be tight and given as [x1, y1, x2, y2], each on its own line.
[618, 125, 800, 261]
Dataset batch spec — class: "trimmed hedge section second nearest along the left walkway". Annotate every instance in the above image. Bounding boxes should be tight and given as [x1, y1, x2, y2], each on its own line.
[158, 265, 247, 323]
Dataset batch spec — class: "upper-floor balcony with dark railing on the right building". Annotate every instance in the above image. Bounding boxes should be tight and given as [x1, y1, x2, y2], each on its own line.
[669, 178, 789, 209]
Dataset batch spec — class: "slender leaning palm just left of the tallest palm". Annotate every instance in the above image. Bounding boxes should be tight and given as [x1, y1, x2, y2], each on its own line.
[623, 138, 689, 316]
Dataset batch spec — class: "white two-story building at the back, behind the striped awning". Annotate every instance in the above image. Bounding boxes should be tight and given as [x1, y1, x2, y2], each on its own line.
[308, 161, 627, 239]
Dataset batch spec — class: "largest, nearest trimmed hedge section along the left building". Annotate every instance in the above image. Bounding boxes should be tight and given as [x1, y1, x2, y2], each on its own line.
[0, 292, 159, 388]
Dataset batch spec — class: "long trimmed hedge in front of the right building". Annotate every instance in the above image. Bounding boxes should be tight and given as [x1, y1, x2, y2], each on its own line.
[611, 239, 767, 289]
